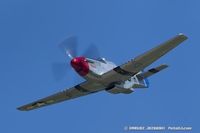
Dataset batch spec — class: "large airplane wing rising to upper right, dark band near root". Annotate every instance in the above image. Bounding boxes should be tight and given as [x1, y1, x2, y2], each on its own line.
[101, 34, 187, 85]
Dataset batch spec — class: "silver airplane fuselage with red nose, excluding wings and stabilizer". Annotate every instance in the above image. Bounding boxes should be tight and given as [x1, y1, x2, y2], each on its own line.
[71, 56, 147, 92]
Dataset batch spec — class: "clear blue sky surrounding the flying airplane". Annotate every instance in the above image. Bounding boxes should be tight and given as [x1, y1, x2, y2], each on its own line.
[0, 0, 200, 133]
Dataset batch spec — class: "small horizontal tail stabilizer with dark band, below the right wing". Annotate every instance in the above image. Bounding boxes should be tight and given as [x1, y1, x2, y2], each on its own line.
[137, 64, 168, 80]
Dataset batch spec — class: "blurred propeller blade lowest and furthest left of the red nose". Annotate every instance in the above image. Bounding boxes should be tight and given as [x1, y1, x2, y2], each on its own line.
[52, 62, 69, 81]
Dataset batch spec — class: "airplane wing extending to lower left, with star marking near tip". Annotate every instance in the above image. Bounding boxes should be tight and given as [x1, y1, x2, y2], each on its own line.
[17, 81, 104, 111]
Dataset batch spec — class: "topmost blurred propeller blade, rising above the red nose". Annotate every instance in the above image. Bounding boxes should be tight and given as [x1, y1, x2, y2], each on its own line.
[59, 36, 78, 59]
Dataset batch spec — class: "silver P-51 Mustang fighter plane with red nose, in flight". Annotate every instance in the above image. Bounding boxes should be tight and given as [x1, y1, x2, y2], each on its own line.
[18, 34, 187, 111]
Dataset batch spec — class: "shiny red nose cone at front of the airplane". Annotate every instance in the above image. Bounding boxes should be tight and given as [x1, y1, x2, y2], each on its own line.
[71, 56, 89, 76]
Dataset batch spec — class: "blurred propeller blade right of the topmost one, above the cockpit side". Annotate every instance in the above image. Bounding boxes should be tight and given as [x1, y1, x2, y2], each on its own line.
[83, 43, 100, 59]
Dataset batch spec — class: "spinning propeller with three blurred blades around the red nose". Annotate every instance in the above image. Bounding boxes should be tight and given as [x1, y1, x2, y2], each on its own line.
[52, 36, 100, 81]
